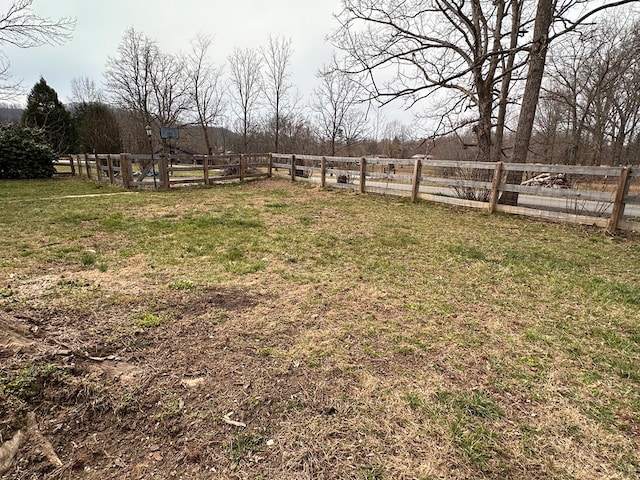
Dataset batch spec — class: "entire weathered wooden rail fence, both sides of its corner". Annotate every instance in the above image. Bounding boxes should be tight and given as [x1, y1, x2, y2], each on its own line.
[57, 153, 640, 232]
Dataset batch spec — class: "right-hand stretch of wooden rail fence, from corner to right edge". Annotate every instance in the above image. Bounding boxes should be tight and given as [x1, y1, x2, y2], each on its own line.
[272, 154, 640, 232]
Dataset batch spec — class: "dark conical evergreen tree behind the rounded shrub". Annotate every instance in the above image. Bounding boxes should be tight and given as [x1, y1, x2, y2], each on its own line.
[22, 78, 77, 154]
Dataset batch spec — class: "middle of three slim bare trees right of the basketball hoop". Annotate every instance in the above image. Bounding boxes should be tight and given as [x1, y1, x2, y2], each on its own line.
[229, 48, 262, 153]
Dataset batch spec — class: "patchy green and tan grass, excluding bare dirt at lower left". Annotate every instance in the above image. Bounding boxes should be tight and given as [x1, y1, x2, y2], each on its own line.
[0, 180, 640, 479]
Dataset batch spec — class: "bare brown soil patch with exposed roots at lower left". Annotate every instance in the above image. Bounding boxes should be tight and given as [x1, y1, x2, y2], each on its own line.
[0, 262, 432, 479]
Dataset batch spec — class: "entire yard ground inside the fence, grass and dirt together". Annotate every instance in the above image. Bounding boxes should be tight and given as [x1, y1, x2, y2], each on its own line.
[0, 179, 640, 480]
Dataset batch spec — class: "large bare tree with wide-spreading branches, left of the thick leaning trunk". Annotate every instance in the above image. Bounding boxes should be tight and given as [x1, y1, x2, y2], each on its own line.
[332, 0, 533, 160]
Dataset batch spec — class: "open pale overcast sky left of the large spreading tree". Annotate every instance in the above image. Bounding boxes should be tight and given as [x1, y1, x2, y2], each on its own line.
[0, 0, 356, 111]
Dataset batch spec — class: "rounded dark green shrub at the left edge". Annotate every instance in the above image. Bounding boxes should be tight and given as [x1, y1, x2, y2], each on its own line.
[0, 125, 56, 179]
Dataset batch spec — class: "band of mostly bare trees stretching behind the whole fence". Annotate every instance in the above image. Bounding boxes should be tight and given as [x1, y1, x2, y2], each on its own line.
[0, 0, 640, 173]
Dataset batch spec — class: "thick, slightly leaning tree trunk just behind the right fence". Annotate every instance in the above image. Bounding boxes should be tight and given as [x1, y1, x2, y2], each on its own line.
[500, 0, 554, 205]
